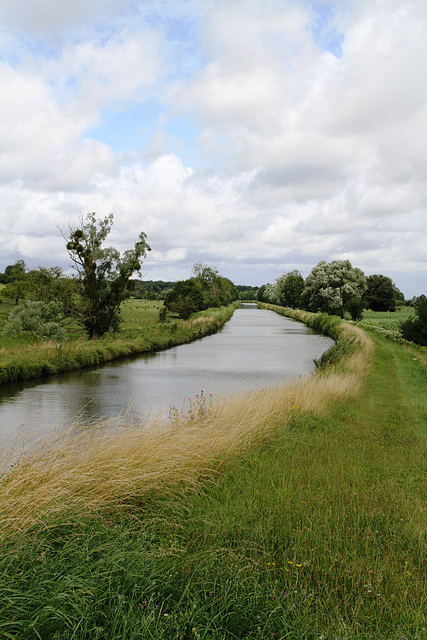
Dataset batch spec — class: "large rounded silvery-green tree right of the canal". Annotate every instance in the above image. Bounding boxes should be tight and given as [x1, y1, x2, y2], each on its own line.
[301, 260, 366, 317]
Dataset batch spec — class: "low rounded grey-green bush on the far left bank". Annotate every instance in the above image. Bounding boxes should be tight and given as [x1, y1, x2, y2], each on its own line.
[3, 301, 67, 344]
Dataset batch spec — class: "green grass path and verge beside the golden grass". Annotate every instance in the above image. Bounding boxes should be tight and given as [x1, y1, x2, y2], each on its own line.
[0, 328, 427, 640]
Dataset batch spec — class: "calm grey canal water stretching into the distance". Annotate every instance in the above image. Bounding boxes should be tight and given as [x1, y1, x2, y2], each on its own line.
[0, 304, 332, 446]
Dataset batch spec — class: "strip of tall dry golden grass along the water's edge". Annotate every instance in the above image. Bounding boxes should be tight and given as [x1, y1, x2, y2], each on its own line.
[0, 324, 372, 537]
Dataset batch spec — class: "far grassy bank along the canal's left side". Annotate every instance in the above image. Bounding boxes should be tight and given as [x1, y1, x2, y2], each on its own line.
[0, 300, 239, 384]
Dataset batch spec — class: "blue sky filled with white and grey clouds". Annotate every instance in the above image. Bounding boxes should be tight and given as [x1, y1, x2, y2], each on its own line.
[0, 0, 427, 298]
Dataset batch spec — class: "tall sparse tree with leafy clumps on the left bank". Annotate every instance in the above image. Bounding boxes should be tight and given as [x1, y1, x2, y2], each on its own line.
[64, 213, 150, 339]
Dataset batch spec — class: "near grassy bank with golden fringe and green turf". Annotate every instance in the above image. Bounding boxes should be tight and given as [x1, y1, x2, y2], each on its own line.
[0, 308, 427, 640]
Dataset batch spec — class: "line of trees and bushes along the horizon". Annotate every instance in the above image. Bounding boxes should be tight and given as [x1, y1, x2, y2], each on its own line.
[0, 213, 427, 345]
